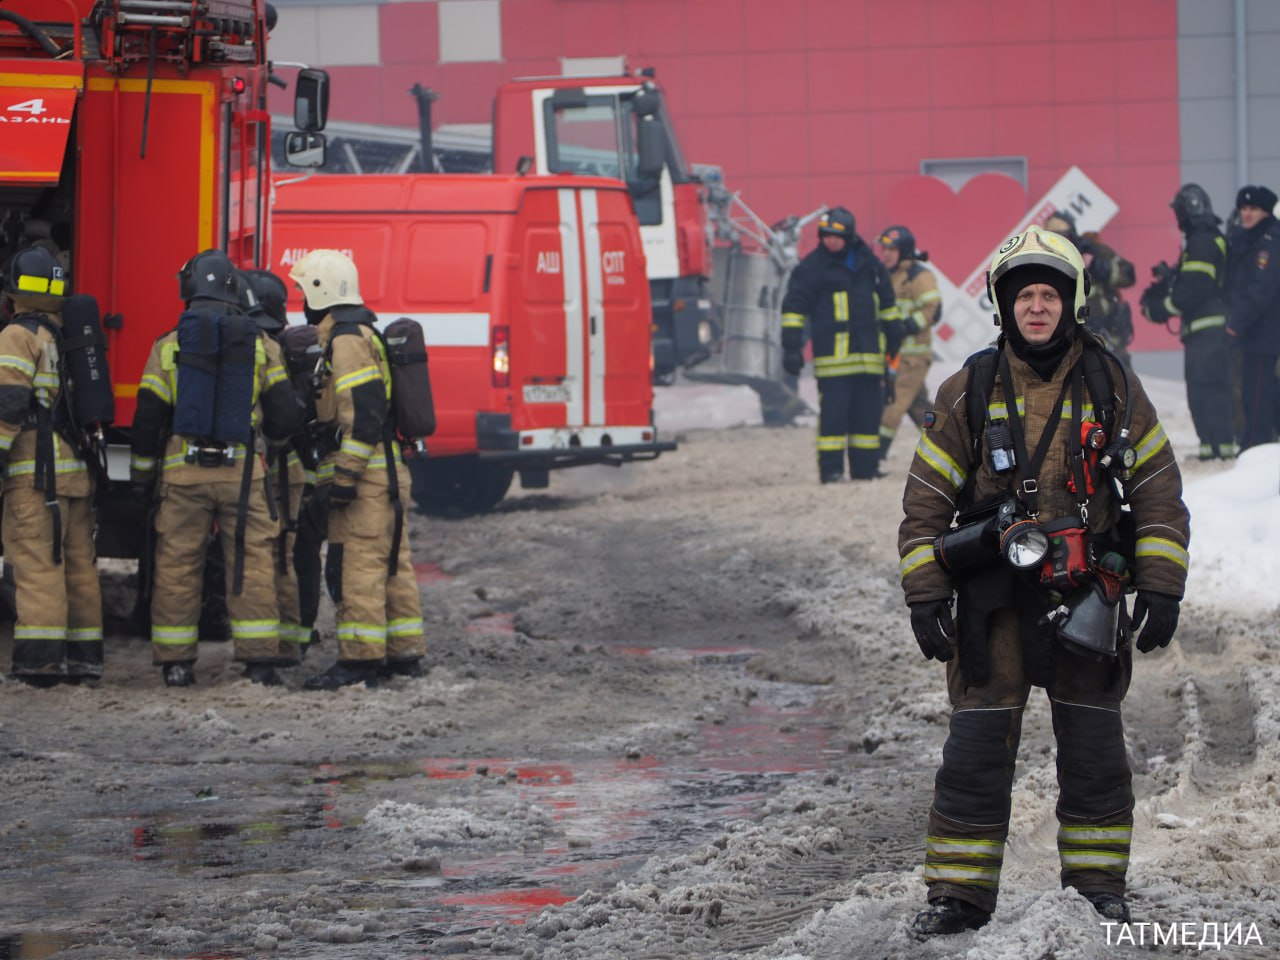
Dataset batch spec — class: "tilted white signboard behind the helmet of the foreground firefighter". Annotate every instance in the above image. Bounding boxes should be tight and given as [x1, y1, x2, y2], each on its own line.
[933, 166, 1120, 367]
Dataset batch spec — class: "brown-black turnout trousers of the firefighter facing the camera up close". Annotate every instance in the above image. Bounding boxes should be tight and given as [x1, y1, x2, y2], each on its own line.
[924, 611, 1133, 911]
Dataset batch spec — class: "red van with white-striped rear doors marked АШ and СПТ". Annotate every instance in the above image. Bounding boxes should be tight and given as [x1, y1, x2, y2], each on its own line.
[273, 174, 676, 512]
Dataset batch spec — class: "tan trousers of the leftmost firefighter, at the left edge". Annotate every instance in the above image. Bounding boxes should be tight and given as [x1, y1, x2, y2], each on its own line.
[3, 486, 102, 678]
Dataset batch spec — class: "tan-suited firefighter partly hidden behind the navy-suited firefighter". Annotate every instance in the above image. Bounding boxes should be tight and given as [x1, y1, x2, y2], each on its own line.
[879, 227, 942, 458]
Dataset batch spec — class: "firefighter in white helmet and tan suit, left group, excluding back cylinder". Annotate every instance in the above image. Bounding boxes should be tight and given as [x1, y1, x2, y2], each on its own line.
[289, 250, 426, 690]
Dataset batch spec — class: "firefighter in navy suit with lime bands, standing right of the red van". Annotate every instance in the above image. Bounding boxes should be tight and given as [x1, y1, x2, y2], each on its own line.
[782, 206, 902, 484]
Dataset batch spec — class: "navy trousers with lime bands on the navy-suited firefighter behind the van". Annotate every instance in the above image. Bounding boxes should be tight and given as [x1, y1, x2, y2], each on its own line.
[818, 374, 884, 480]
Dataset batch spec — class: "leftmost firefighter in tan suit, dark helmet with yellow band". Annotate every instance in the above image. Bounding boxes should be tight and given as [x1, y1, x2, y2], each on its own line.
[0, 247, 102, 686]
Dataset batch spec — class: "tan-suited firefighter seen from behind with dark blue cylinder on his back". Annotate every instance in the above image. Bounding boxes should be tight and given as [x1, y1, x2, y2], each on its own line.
[129, 250, 302, 686]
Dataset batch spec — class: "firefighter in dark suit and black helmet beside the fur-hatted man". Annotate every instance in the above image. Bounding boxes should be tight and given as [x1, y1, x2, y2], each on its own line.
[1142, 183, 1235, 460]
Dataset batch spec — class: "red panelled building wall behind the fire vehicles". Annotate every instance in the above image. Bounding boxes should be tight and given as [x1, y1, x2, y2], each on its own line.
[277, 0, 1179, 348]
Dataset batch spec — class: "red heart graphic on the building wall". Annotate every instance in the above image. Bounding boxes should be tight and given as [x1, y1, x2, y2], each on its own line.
[887, 173, 1028, 284]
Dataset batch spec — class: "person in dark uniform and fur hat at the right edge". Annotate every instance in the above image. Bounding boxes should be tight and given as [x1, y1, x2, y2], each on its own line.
[1226, 187, 1280, 449]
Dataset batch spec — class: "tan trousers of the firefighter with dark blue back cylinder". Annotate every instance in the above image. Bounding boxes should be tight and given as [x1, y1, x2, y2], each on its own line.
[151, 476, 280, 666]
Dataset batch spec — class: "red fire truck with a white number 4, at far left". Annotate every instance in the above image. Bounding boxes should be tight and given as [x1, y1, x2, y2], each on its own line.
[0, 0, 328, 557]
